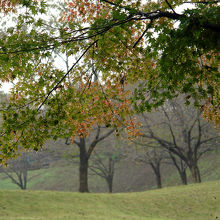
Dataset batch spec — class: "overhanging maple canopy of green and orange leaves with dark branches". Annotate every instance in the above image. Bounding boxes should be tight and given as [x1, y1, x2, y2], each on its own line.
[0, 0, 220, 162]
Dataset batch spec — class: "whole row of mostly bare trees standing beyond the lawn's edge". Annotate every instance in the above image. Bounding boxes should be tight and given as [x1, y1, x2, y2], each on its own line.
[2, 97, 220, 192]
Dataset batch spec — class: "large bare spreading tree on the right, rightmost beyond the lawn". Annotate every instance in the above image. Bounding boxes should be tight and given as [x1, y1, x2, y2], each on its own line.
[142, 97, 220, 183]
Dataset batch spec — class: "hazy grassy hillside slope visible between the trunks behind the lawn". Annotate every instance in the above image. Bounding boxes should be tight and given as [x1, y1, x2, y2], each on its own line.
[0, 151, 220, 192]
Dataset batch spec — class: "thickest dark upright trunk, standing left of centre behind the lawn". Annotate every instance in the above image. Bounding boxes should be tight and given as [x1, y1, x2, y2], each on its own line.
[79, 138, 89, 192]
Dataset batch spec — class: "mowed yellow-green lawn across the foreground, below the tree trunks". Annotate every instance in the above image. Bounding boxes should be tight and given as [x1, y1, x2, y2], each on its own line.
[0, 181, 220, 220]
